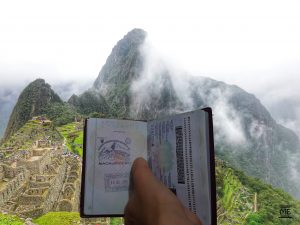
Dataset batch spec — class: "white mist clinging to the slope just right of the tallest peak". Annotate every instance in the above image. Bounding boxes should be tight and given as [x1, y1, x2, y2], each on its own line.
[131, 39, 246, 144]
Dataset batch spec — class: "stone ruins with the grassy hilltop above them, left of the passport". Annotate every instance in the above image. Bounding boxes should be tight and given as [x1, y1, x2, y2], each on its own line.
[0, 117, 81, 218]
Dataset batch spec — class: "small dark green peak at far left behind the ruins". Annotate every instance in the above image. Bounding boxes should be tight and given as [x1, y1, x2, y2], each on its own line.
[3, 79, 76, 141]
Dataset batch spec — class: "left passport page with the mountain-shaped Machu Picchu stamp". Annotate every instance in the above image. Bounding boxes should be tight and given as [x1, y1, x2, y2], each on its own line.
[84, 119, 147, 215]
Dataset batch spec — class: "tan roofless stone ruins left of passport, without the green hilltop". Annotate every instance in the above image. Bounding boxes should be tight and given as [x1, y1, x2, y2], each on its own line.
[0, 138, 81, 218]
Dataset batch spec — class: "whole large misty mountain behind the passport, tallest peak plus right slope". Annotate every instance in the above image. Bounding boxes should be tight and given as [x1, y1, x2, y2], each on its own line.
[69, 29, 300, 198]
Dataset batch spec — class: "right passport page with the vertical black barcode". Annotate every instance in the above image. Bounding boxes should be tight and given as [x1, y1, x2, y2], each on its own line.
[148, 110, 210, 224]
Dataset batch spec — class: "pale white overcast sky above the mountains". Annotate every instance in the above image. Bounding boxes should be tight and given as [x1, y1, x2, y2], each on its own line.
[0, 0, 300, 133]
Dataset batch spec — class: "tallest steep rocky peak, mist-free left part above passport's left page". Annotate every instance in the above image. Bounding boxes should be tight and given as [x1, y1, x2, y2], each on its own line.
[68, 29, 146, 117]
